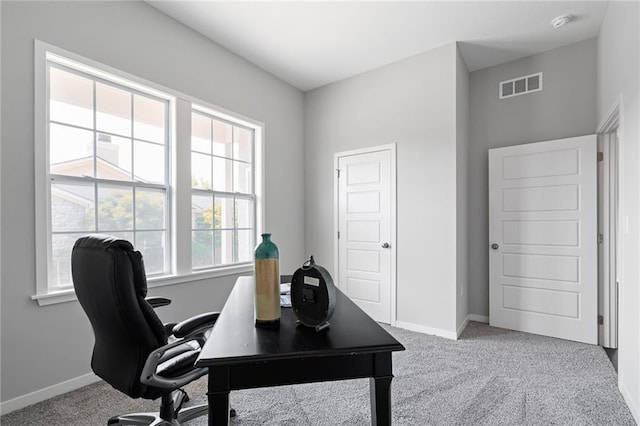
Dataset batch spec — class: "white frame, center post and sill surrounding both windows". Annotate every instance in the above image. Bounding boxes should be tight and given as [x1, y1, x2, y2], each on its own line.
[31, 40, 265, 306]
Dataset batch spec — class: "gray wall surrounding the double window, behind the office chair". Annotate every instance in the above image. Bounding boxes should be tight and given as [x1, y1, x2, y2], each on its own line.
[0, 2, 304, 401]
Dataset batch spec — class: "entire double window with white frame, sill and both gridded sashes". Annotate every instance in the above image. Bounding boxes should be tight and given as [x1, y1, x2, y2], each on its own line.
[33, 42, 262, 304]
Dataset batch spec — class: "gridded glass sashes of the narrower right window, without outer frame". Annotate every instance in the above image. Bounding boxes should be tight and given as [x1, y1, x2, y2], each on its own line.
[191, 110, 256, 270]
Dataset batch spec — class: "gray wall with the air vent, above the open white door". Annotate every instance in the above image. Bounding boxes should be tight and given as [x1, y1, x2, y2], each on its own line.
[468, 39, 596, 316]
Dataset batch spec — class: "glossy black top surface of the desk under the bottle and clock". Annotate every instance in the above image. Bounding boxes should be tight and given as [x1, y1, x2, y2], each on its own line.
[196, 277, 404, 367]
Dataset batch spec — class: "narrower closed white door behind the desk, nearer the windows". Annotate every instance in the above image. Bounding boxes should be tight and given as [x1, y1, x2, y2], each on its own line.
[336, 148, 395, 324]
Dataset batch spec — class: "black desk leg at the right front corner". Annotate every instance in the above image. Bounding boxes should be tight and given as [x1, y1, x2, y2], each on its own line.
[369, 352, 393, 426]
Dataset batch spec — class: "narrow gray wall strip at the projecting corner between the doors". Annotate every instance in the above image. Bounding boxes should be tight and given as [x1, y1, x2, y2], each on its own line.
[454, 50, 469, 331]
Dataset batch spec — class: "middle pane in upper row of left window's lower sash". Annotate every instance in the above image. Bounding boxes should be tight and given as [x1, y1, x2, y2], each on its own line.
[98, 186, 133, 232]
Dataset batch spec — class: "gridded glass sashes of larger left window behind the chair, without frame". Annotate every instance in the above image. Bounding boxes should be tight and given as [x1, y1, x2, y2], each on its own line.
[47, 60, 170, 291]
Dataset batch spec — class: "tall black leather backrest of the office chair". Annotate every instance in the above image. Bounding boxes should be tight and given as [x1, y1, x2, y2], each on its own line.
[71, 234, 167, 398]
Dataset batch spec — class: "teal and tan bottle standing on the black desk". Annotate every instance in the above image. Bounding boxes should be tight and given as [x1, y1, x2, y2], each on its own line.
[253, 234, 280, 327]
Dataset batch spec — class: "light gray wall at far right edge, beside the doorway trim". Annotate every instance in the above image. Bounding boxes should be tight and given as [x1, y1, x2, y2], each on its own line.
[597, 2, 640, 423]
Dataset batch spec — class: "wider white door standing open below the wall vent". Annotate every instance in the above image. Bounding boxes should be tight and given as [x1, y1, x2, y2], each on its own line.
[489, 135, 598, 344]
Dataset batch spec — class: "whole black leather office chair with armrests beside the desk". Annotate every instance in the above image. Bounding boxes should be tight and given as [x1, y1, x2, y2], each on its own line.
[71, 235, 228, 425]
